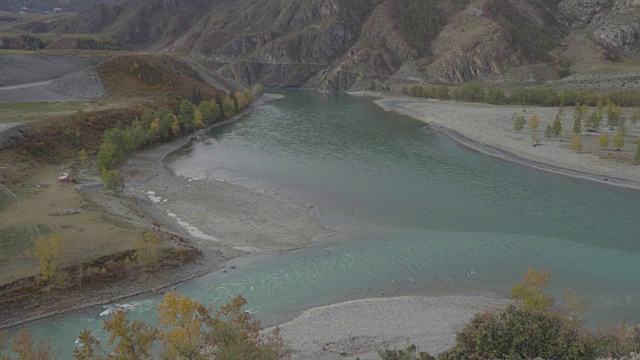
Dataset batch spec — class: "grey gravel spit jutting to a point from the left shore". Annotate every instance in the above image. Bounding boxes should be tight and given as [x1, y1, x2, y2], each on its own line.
[0, 94, 329, 329]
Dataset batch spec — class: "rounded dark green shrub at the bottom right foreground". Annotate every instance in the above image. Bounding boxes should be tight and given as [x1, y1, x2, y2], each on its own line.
[439, 305, 596, 360]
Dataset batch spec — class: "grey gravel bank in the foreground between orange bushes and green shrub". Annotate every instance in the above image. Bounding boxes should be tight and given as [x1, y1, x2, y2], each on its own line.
[279, 296, 508, 360]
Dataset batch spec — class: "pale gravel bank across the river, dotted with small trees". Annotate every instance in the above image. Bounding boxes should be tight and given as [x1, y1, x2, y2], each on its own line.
[353, 92, 640, 190]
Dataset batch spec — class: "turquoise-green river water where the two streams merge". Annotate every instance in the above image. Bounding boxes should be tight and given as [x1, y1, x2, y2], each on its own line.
[10, 91, 640, 356]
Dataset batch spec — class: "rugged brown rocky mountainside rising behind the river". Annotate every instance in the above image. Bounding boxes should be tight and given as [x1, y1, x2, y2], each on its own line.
[0, 0, 640, 90]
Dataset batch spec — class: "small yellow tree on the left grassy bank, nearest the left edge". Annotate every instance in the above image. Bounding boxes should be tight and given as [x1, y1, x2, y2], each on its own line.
[27, 235, 67, 291]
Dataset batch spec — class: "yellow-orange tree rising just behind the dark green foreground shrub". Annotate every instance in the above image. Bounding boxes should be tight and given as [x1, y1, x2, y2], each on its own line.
[509, 268, 554, 311]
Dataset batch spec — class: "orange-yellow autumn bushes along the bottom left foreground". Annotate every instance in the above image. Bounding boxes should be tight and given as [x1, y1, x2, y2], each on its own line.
[0, 293, 290, 360]
